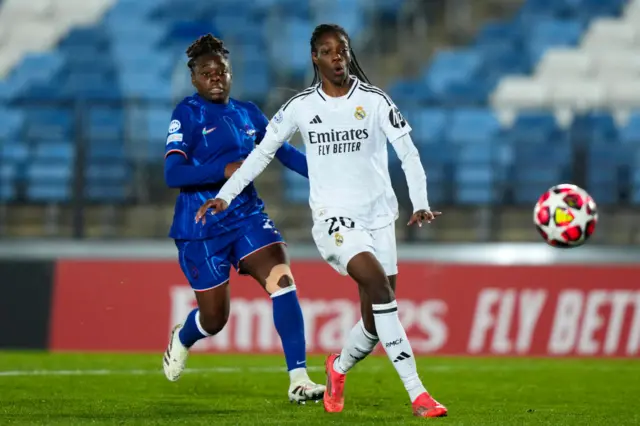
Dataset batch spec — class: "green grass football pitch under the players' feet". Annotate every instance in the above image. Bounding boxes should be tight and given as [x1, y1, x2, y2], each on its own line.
[0, 352, 640, 426]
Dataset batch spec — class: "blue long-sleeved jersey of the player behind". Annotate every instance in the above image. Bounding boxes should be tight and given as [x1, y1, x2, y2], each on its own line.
[165, 94, 307, 240]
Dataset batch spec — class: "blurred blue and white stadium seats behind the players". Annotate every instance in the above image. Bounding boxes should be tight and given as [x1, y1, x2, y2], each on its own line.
[0, 0, 640, 205]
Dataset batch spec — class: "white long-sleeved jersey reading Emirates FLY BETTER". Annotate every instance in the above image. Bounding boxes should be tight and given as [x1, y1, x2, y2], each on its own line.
[218, 78, 429, 229]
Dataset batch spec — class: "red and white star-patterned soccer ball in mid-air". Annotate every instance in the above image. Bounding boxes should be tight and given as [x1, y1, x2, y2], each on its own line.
[533, 184, 598, 248]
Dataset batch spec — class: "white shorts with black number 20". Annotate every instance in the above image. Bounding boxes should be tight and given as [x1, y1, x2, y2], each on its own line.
[311, 217, 398, 276]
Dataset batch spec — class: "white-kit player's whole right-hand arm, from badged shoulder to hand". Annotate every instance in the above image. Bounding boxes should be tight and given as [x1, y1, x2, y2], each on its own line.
[378, 98, 442, 226]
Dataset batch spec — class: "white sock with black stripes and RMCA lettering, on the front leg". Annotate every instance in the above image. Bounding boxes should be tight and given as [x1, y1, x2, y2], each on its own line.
[372, 300, 427, 402]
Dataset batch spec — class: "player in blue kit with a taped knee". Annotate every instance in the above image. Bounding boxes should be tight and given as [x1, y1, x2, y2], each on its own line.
[163, 34, 325, 403]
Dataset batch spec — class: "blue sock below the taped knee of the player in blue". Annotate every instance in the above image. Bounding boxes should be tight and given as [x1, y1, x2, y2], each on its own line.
[271, 286, 307, 371]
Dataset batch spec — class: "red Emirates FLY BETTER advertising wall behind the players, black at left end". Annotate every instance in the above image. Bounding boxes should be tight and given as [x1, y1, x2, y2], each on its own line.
[0, 242, 640, 357]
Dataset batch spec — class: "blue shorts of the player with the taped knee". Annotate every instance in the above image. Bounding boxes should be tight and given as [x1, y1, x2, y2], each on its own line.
[176, 214, 284, 291]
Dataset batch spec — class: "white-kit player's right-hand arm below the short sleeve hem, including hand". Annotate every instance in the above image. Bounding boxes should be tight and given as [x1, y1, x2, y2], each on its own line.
[391, 133, 442, 226]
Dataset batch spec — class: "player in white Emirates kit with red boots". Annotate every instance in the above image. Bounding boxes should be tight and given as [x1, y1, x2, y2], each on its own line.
[196, 24, 447, 417]
